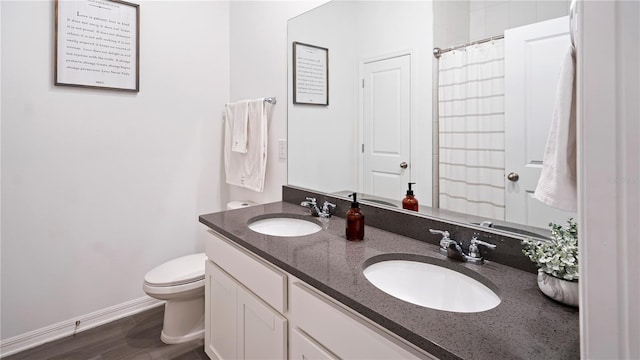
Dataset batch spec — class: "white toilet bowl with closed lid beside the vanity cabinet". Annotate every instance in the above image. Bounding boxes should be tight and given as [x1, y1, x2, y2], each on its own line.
[143, 253, 207, 344]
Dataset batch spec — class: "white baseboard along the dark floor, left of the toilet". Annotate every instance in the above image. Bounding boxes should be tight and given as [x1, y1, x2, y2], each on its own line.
[0, 296, 164, 358]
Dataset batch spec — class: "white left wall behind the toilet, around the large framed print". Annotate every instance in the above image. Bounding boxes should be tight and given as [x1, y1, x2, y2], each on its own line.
[1, 1, 230, 339]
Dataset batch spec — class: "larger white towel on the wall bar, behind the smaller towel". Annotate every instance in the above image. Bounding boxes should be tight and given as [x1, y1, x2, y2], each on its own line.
[224, 99, 268, 192]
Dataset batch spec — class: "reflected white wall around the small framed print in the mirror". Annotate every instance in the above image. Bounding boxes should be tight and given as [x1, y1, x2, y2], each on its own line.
[287, 1, 359, 192]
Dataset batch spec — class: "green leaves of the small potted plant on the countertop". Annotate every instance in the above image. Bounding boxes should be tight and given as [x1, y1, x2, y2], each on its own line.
[522, 219, 578, 281]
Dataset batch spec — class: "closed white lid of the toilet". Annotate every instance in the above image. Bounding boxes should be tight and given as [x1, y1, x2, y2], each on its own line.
[144, 253, 207, 286]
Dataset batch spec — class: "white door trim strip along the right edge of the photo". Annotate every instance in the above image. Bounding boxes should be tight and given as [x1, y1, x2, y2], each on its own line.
[576, 1, 640, 359]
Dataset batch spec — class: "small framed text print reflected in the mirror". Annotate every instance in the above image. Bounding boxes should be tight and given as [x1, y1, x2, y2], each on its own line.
[293, 41, 329, 105]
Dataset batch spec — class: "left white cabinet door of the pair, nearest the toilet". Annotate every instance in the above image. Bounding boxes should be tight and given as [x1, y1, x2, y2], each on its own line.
[205, 261, 238, 360]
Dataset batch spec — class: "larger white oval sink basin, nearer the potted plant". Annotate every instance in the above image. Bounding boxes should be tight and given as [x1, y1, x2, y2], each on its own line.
[363, 260, 500, 313]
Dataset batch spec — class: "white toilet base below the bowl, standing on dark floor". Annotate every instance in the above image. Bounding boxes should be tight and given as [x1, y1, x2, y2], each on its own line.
[160, 289, 204, 344]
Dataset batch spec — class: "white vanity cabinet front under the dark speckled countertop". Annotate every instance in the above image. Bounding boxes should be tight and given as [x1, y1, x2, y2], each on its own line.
[205, 231, 432, 360]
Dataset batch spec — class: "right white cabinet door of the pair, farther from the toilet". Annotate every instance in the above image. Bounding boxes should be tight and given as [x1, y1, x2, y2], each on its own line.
[238, 287, 287, 359]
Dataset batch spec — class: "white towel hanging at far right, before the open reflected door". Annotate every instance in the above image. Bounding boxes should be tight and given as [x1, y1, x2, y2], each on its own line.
[533, 48, 577, 212]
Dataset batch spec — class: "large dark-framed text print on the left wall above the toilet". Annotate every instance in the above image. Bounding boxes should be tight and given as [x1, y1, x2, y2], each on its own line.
[54, 0, 140, 92]
